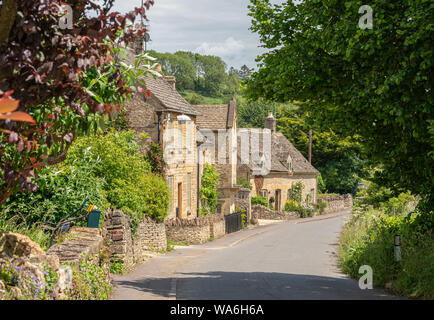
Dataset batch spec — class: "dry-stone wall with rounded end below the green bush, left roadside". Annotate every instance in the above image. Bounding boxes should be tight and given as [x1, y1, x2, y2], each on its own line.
[104, 210, 167, 269]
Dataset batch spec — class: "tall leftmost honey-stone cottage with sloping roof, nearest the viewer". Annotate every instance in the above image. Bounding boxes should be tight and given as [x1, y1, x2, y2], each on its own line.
[125, 44, 199, 218]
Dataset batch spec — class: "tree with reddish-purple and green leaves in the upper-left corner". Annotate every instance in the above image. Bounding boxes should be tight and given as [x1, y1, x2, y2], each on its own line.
[0, 0, 153, 204]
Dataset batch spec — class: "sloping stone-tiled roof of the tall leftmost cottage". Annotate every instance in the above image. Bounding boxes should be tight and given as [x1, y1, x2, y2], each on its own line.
[126, 48, 197, 115]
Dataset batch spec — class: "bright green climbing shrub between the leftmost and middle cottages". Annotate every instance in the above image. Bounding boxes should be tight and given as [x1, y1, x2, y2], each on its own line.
[200, 163, 219, 216]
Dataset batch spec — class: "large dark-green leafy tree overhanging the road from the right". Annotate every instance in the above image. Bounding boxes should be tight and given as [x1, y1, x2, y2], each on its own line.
[248, 0, 434, 211]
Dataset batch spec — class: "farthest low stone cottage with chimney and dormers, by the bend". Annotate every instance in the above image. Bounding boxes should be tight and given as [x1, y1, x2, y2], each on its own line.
[237, 112, 319, 211]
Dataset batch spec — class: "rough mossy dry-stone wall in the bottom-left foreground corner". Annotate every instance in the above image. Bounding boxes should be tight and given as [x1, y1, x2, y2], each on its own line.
[0, 227, 110, 300]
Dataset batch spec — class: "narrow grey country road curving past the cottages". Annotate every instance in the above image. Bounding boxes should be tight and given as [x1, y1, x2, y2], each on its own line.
[111, 212, 397, 300]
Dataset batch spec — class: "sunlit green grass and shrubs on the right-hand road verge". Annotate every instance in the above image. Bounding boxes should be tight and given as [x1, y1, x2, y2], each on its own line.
[339, 209, 434, 299]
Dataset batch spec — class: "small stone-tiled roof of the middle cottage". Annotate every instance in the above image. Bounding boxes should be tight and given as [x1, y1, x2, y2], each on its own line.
[193, 100, 236, 130]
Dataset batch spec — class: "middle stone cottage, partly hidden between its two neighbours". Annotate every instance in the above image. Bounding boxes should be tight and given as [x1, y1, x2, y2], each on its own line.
[193, 99, 240, 214]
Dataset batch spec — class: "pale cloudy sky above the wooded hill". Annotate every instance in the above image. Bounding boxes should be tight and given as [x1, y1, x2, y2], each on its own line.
[114, 0, 274, 69]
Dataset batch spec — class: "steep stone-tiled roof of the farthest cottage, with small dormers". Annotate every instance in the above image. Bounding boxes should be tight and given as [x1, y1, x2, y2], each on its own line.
[238, 129, 319, 174]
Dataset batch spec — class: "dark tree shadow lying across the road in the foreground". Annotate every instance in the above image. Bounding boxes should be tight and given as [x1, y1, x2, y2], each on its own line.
[113, 271, 398, 300]
